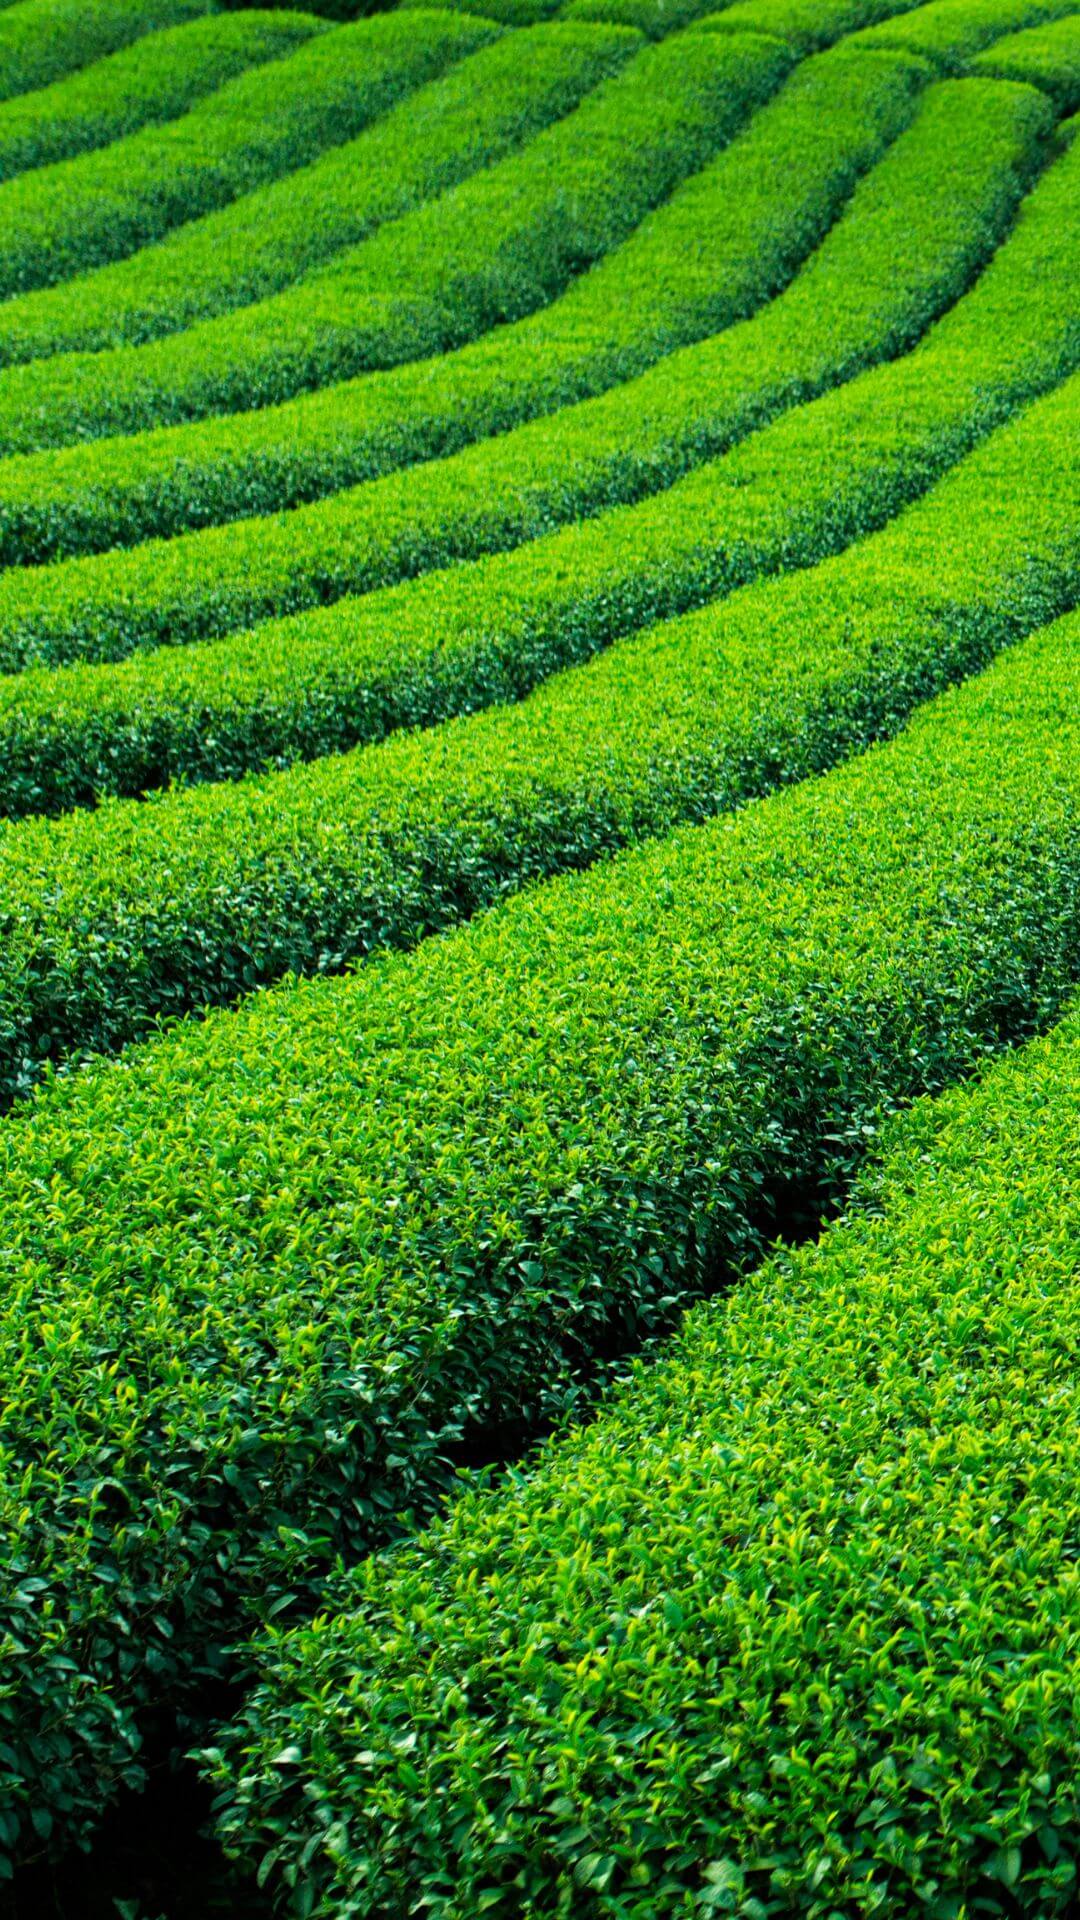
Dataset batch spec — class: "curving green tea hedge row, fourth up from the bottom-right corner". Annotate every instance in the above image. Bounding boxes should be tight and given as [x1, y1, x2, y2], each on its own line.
[0, 151, 1080, 816]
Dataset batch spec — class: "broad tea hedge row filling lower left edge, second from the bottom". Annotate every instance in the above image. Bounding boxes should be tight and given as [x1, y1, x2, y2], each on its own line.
[0, 549, 1080, 1849]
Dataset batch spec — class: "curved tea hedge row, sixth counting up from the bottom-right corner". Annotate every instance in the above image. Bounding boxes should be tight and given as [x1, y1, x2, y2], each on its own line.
[0, 29, 922, 556]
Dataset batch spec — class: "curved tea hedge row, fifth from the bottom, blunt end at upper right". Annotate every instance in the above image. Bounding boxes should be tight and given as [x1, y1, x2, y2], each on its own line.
[0, 81, 1045, 648]
